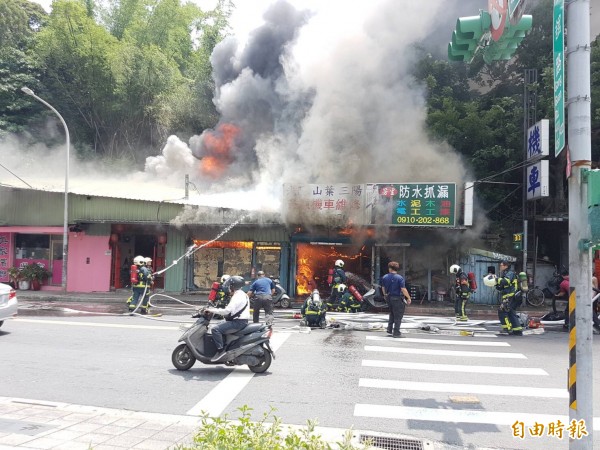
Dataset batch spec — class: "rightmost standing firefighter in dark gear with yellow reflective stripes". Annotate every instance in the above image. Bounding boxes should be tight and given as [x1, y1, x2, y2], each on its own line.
[496, 261, 523, 336]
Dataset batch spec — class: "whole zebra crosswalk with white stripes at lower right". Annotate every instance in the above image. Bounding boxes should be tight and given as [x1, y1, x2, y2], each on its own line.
[354, 333, 600, 449]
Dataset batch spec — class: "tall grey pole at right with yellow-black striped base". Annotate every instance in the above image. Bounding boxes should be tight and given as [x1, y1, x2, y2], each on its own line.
[566, 0, 594, 450]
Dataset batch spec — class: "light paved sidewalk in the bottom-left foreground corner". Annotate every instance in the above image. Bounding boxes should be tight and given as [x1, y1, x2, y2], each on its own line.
[0, 397, 201, 450]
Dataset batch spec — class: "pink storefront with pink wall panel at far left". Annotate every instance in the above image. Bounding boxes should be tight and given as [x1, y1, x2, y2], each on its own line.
[0, 226, 111, 292]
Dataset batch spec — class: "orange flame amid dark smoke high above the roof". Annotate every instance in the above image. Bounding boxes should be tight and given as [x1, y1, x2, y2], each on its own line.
[200, 123, 240, 178]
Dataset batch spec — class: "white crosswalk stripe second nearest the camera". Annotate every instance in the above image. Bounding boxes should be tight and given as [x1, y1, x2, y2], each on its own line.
[358, 378, 569, 398]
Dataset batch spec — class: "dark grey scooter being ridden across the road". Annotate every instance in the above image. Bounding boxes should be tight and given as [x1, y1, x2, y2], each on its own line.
[171, 309, 275, 373]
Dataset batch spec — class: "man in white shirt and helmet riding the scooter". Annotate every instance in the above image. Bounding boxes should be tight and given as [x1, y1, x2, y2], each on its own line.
[206, 275, 250, 362]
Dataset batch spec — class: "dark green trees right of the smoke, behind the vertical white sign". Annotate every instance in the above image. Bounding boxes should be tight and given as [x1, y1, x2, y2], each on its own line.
[415, 0, 564, 246]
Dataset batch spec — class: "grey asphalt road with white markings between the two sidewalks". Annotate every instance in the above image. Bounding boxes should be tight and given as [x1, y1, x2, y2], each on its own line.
[0, 311, 600, 449]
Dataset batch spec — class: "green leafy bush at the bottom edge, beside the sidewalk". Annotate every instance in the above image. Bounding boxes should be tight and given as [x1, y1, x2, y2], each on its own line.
[177, 406, 368, 450]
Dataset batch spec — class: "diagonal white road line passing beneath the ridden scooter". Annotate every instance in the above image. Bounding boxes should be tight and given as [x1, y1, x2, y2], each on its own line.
[186, 333, 290, 417]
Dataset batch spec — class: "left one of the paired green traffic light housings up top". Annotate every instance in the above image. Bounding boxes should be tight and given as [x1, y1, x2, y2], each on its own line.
[448, 10, 492, 62]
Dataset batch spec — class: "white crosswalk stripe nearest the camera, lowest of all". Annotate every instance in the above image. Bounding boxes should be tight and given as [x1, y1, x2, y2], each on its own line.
[354, 404, 600, 430]
